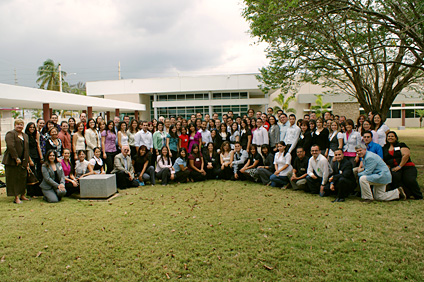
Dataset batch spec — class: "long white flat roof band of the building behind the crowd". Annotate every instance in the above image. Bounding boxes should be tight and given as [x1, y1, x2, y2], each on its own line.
[86, 73, 262, 96]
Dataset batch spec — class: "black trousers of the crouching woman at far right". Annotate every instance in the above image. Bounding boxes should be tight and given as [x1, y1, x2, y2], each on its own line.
[391, 166, 423, 199]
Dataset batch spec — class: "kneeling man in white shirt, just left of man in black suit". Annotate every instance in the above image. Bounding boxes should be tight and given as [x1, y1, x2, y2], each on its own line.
[306, 145, 330, 197]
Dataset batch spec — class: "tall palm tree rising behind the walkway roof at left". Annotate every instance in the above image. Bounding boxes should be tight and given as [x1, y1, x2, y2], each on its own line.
[37, 59, 66, 91]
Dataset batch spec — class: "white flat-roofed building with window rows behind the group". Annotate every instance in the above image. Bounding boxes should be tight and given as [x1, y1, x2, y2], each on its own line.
[86, 74, 424, 127]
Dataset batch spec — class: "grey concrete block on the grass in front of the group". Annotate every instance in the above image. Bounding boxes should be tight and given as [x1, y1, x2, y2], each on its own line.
[80, 174, 117, 198]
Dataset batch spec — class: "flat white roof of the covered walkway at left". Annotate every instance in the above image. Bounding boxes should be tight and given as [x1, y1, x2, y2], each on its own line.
[0, 83, 146, 112]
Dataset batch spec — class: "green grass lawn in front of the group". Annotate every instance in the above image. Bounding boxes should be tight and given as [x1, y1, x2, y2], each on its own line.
[0, 131, 424, 281]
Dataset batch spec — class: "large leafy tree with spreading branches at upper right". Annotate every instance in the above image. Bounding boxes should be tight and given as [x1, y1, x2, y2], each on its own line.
[244, 0, 424, 118]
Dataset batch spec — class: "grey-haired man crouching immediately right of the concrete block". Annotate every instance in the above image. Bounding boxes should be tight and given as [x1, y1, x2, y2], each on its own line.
[112, 145, 138, 189]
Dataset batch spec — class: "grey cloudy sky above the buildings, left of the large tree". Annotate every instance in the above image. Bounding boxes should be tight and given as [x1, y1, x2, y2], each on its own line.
[0, 0, 267, 87]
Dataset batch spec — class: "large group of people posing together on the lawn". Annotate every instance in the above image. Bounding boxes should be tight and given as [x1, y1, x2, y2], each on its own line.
[3, 108, 423, 204]
